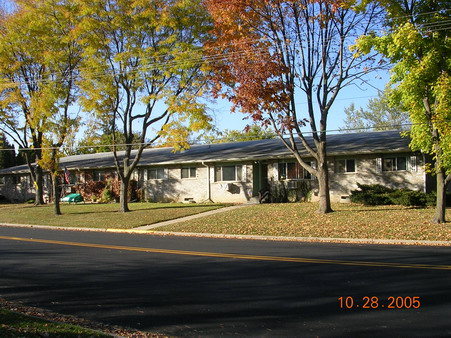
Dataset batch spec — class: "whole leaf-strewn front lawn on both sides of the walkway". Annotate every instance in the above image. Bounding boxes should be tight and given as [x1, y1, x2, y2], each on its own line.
[0, 203, 451, 241]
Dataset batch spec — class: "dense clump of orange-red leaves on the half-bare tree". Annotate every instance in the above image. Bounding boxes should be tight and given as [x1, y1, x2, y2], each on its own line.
[206, 0, 290, 121]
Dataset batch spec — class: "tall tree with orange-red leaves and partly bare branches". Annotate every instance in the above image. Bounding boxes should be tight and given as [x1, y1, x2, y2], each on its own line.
[205, 0, 380, 213]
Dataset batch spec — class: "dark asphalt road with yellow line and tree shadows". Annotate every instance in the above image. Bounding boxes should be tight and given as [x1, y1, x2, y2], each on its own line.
[0, 227, 451, 337]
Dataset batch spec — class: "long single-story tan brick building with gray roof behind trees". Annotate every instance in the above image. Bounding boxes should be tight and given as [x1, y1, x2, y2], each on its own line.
[0, 131, 434, 203]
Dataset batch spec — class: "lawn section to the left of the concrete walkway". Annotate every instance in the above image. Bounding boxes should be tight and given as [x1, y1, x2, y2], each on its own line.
[0, 203, 224, 229]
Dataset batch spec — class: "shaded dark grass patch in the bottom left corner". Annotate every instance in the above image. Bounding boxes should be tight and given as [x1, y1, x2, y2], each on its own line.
[0, 309, 111, 338]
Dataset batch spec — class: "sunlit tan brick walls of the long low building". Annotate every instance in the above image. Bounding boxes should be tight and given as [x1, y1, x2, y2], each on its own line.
[0, 153, 425, 203]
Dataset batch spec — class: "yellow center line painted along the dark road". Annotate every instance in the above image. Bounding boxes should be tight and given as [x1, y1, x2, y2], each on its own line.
[0, 236, 451, 270]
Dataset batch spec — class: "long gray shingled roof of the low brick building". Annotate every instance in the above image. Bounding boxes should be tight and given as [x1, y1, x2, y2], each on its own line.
[0, 131, 410, 174]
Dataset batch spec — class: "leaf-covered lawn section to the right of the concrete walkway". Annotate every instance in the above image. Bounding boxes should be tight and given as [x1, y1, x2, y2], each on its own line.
[157, 203, 451, 241]
